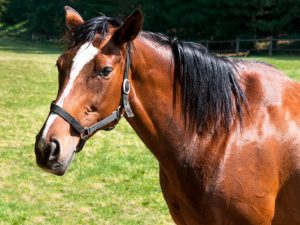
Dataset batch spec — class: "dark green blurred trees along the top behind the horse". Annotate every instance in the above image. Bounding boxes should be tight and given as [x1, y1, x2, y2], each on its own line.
[0, 0, 300, 40]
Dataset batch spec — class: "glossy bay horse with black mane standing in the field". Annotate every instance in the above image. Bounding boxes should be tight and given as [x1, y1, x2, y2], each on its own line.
[35, 7, 300, 225]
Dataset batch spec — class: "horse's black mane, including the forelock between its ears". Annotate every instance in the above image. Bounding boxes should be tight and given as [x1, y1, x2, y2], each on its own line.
[71, 15, 246, 134]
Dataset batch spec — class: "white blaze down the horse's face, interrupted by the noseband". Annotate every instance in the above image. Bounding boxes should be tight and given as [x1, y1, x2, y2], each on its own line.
[42, 42, 98, 140]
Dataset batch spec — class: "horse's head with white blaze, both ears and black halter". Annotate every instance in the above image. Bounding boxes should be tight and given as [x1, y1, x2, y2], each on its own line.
[35, 7, 143, 175]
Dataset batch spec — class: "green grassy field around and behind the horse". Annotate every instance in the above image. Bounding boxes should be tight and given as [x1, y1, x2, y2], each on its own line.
[0, 40, 300, 225]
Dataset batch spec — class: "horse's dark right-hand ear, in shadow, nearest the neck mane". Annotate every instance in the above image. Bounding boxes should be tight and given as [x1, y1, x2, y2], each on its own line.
[113, 10, 144, 44]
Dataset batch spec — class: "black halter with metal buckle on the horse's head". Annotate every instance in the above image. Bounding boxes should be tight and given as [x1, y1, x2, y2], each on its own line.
[50, 45, 134, 152]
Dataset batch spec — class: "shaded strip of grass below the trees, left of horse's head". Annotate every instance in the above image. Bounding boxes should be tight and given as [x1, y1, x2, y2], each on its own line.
[0, 38, 63, 54]
